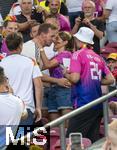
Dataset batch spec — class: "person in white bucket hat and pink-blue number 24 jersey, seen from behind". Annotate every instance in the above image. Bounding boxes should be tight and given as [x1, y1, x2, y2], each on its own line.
[64, 27, 114, 142]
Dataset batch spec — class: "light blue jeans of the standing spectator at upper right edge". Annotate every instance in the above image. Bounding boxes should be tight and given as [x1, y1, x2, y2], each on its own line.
[106, 21, 117, 43]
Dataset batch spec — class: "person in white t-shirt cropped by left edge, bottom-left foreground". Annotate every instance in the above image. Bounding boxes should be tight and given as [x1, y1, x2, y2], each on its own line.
[0, 67, 24, 150]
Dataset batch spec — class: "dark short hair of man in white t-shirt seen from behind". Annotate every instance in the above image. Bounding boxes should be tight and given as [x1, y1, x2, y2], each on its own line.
[6, 33, 23, 51]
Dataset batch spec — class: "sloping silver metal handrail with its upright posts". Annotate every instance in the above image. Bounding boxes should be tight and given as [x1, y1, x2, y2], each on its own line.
[14, 90, 117, 150]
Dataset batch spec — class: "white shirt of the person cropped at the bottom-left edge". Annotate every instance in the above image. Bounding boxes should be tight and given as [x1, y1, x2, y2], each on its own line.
[0, 93, 24, 125]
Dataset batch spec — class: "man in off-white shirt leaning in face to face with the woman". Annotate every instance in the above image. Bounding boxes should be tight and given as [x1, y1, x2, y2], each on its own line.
[21, 23, 58, 63]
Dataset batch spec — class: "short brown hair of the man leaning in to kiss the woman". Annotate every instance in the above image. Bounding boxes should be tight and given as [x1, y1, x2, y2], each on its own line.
[38, 23, 57, 34]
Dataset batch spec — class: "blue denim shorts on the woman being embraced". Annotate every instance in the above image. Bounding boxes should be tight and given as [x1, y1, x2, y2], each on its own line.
[47, 85, 73, 112]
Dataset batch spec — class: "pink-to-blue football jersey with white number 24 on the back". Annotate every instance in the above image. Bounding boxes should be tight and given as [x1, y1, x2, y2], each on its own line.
[70, 48, 110, 107]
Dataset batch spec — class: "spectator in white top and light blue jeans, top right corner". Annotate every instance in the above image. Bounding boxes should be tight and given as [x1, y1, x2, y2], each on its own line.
[104, 0, 117, 43]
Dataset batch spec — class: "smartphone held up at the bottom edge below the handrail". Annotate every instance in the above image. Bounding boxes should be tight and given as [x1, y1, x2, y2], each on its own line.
[69, 132, 83, 150]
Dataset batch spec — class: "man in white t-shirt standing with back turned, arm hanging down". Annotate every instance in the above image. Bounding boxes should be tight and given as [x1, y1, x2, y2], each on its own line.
[0, 33, 42, 125]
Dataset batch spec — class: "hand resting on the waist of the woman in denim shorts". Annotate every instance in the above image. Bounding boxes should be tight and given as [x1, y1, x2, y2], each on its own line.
[57, 78, 71, 88]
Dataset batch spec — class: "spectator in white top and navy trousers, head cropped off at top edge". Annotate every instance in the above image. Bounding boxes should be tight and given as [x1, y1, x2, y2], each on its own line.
[66, 0, 83, 28]
